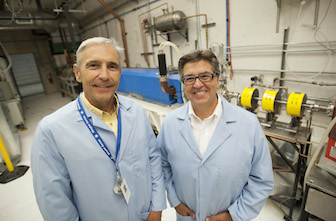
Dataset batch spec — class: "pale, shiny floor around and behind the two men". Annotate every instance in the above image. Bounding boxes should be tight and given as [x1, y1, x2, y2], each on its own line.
[0, 93, 283, 221]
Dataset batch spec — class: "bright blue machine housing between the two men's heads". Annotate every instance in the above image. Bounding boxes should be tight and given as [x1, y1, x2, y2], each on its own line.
[118, 68, 183, 105]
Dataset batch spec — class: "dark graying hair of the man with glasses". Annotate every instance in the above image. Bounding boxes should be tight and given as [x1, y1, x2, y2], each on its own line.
[178, 50, 220, 78]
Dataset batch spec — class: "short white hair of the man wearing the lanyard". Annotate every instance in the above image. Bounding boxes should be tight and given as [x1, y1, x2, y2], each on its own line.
[76, 37, 124, 69]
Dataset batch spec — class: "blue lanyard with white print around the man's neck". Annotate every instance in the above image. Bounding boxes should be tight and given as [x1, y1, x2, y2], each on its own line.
[77, 95, 121, 172]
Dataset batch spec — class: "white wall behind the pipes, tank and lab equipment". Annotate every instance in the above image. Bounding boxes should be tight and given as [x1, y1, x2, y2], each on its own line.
[82, 0, 336, 127]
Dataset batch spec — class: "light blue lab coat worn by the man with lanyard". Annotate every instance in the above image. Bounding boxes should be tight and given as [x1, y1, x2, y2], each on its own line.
[31, 96, 166, 221]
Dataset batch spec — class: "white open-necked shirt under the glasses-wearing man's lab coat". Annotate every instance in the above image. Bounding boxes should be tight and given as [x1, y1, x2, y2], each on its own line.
[188, 94, 223, 156]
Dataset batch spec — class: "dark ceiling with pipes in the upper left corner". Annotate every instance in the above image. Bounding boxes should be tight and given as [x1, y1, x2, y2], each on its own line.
[0, 0, 138, 30]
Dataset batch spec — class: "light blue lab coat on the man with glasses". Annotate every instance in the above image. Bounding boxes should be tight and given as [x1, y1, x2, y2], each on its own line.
[158, 96, 274, 221]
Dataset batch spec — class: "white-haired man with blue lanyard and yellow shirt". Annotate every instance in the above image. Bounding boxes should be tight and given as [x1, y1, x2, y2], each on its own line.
[31, 37, 166, 221]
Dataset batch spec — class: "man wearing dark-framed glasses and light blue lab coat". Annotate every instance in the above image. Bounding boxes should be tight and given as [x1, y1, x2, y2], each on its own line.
[158, 50, 273, 221]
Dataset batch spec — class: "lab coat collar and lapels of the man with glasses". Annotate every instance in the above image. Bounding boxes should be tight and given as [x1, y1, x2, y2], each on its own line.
[177, 95, 238, 164]
